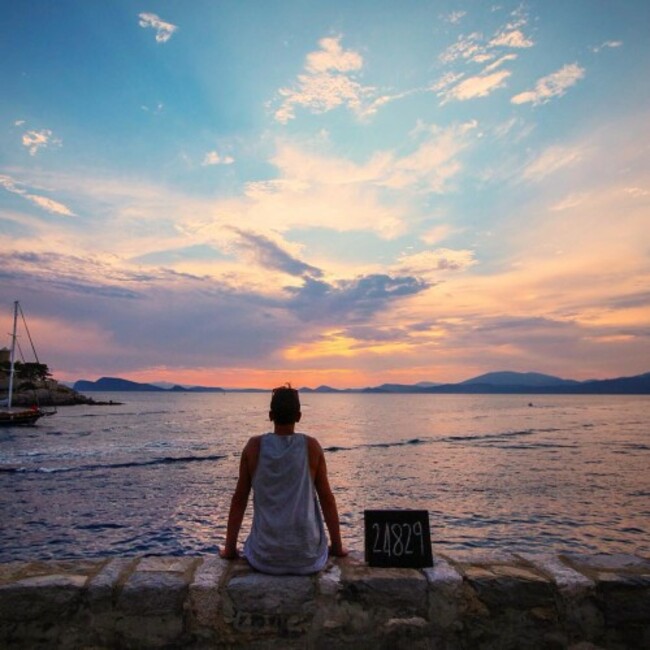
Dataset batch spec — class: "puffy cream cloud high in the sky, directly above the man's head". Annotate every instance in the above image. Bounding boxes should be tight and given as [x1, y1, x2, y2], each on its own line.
[275, 36, 374, 124]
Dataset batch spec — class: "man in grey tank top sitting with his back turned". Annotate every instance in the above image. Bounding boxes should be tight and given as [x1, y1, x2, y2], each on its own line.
[220, 385, 347, 575]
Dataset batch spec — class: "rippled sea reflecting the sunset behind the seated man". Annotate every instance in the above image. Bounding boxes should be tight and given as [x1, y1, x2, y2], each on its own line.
[0, 393, 650, 562]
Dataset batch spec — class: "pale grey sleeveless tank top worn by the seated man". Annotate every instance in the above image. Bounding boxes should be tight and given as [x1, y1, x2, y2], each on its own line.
[244, 433, 327, 575]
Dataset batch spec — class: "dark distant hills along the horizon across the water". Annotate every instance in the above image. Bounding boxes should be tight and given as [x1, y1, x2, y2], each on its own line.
[73, 371, 650, 395]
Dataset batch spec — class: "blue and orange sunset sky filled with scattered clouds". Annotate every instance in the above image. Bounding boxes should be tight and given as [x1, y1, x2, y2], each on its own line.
[0, 0, 650, 388]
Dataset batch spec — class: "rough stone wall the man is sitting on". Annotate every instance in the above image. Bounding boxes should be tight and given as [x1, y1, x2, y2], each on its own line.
[0, 552, 650, 650]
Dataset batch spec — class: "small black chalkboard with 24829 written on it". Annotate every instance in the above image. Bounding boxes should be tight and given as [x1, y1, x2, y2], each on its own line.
[363, 510, 433, 569]
